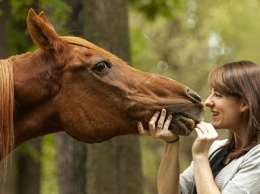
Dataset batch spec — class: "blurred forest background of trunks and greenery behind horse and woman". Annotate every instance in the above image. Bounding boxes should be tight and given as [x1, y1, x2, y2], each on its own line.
[0, 0, 260, 194]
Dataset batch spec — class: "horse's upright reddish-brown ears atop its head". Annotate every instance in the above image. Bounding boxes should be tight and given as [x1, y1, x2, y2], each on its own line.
[27, 9, 62, 51]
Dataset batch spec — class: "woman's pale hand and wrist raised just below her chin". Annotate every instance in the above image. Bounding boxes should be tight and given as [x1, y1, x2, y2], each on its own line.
[192, 122, 218, 157]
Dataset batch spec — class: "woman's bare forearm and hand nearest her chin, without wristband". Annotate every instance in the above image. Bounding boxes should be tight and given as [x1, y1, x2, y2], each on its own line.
[192, 122, 220, 194]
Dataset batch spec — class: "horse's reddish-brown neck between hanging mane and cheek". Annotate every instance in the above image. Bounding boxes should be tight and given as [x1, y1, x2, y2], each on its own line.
[6, 51, 63, 150]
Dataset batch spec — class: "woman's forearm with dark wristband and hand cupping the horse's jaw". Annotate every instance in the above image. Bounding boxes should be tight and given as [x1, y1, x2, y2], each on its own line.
[138, 109, 180, 194]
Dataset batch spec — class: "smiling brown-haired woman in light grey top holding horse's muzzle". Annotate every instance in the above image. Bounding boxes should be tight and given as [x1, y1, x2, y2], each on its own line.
[138, 61, 260, 194]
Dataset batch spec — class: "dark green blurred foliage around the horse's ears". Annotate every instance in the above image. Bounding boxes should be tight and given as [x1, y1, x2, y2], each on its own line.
[7, 0, 72, 55]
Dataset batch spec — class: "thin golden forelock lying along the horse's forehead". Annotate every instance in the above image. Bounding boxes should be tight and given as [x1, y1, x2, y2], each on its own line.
[61, 36, 123, 61]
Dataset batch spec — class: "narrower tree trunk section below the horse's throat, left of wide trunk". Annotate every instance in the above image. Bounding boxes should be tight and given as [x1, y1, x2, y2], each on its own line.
[55, 133, 86, 194]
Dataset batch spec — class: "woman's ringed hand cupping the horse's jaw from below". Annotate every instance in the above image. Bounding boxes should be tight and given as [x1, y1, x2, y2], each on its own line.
[137, 109, 179, 142]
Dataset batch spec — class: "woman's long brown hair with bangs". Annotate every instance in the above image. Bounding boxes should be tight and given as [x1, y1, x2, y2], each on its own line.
[208, 61, 260, 159]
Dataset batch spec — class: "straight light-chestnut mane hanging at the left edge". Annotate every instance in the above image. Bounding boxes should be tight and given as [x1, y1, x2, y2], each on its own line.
[0, 60, 14, 159]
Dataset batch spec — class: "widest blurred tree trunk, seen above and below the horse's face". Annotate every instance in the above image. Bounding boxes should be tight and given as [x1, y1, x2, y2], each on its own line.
[84, 0, 143, 194]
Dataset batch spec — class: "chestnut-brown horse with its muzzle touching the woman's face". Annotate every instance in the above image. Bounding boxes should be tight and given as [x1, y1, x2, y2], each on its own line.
[0, 9, 203, 159]
